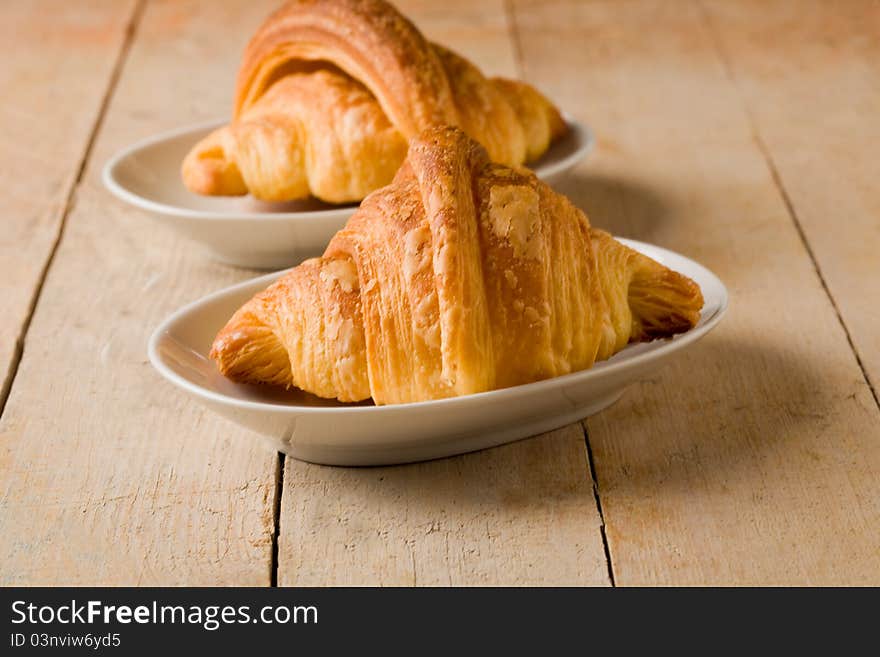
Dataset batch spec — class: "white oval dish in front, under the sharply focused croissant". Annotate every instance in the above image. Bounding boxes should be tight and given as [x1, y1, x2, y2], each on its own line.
[148, 239, 728, 465]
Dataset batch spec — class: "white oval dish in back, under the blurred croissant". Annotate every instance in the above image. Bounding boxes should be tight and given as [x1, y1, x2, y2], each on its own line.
[102, 120, 594, 269]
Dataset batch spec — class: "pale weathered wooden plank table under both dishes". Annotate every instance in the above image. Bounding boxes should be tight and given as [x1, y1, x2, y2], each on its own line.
[0, 0, 880, 585]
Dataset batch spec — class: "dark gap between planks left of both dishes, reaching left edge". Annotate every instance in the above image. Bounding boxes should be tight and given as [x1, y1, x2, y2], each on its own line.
[0, 0, 146, 417]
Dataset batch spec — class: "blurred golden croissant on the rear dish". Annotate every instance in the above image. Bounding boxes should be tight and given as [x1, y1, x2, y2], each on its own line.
[182, 0, 566, 203]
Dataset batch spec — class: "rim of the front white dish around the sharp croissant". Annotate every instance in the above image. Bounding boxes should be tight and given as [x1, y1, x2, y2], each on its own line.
[147, 237, 730, 415]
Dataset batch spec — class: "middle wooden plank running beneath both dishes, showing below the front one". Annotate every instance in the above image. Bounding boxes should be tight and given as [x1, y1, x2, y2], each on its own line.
[278, 0, 609, 586]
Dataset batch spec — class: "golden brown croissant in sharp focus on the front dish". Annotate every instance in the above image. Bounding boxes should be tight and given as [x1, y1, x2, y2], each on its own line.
[211, 128, 703, 404]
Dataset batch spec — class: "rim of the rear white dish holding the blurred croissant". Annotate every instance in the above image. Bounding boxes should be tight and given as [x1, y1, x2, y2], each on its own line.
[101, 112, 596, 222]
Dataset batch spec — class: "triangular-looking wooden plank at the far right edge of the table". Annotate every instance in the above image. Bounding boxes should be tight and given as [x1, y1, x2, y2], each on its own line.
[705, 0, 880, 399]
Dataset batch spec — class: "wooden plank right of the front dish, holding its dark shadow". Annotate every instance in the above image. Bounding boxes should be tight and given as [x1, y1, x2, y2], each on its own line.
[515, 0, 880, 585]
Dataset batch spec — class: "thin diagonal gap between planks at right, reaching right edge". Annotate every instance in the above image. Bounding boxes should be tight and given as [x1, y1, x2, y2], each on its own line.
[696, 0, 880, 408]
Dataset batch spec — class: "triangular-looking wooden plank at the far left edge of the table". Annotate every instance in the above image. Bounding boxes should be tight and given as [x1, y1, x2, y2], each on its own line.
[0, 0, 134, 409]
